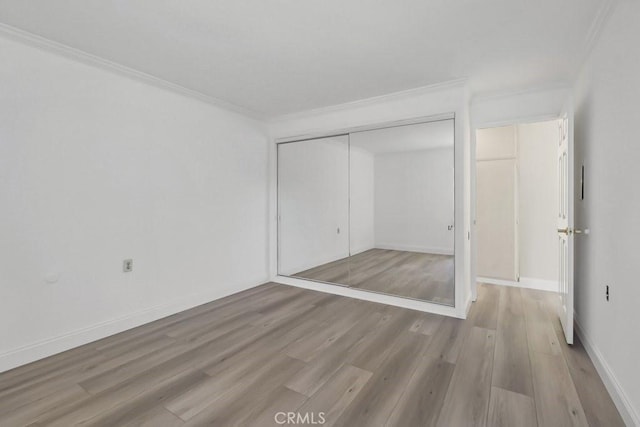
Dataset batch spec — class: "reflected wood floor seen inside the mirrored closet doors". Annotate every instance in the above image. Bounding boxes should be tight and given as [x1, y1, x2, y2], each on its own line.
[294, 249, 454, 305]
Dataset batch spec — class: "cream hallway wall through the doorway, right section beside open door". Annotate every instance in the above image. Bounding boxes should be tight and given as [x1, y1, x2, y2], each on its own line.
[516, 120, 558, 282]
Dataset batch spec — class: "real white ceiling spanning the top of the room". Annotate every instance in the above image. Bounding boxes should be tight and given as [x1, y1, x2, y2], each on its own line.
[0, 0, 605, 117]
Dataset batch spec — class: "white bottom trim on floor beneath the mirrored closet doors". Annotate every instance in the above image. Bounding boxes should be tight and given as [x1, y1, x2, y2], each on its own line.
[272, 276, 467, 319]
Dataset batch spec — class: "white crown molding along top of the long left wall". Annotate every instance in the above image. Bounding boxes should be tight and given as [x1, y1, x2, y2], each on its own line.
[0, 23, 265, 120]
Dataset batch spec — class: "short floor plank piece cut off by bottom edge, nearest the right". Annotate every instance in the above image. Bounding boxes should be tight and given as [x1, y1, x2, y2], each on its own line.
[487, 387, 538, 427]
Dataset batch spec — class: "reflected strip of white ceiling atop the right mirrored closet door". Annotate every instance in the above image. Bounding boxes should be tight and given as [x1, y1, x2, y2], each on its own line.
[349, 120, 454, 155]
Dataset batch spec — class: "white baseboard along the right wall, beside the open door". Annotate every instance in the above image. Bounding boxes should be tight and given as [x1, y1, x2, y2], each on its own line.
[574, 312, 640, 426]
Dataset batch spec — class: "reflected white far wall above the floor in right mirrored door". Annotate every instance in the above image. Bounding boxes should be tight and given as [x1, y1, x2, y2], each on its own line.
[374, 147, 454, 255]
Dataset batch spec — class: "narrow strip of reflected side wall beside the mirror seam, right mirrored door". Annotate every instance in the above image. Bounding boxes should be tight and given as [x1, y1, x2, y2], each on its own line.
[349, 145, 375, 255]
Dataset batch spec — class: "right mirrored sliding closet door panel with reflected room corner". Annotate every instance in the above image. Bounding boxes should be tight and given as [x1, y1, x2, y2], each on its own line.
[349, 120, 454, 305]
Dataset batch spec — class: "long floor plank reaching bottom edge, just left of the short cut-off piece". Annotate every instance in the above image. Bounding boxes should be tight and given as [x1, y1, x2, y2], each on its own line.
[436, 327, 495, 427]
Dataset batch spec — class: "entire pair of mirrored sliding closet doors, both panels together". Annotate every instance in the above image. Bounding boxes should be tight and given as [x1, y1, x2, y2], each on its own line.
[278, 120, 454, 305]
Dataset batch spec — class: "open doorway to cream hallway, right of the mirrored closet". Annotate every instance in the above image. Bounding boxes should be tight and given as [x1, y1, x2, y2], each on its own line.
[475, 119, 560, 292]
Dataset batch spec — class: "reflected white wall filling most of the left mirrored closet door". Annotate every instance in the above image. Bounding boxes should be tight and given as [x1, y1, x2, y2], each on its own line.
[278, 136, 349, 275]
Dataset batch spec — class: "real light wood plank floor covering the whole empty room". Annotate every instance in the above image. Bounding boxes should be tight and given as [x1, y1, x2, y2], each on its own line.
[0, 284, 623, 427]
